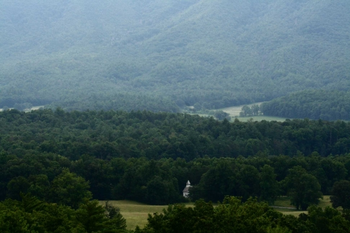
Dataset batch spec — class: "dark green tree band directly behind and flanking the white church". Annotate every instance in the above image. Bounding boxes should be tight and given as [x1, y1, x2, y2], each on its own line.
[0, 153, 350, 209]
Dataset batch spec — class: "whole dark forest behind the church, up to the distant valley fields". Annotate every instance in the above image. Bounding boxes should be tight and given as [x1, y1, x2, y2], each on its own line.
[0, 109, 350, 206]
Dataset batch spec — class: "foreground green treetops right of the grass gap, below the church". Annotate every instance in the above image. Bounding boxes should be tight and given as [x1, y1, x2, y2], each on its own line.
[140, 197, 350, 233]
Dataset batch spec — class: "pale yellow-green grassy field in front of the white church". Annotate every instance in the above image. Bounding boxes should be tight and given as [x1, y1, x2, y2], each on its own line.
[100, 196, 331, 230]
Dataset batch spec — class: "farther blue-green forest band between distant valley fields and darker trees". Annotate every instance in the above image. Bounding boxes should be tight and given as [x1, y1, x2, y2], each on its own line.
[0, 108, 350, 161]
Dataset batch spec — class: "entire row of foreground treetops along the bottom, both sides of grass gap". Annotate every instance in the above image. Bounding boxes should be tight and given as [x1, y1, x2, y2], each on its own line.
[4, 194, 350, 233]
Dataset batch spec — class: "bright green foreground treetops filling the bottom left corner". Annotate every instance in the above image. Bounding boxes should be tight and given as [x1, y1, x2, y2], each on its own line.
[0, 195, 126, 233]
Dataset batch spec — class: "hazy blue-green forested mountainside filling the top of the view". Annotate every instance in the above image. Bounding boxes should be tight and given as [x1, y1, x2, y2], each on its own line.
[0, 0, 350, 111]
